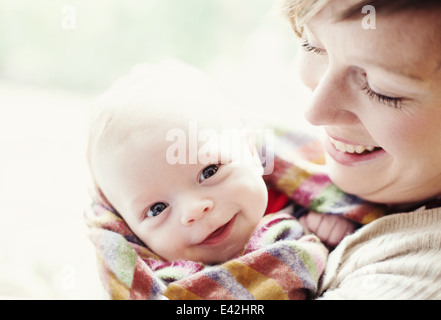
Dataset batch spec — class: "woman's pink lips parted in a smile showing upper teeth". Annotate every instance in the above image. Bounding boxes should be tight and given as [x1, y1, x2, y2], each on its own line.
[325, 136, 386, 166]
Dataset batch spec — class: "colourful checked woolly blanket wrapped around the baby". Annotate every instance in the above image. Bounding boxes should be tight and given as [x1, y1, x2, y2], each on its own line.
[85, 130, 383, 300]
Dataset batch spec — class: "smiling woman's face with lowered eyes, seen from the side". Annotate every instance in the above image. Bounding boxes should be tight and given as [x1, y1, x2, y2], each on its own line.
[299, 0, 441, 204]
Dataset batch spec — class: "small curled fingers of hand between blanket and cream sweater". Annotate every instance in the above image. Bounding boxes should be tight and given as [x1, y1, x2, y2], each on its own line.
[299, 211, 355, 249]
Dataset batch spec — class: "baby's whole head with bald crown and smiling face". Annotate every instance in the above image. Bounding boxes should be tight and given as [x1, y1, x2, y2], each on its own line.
[88, 63, 267, 264]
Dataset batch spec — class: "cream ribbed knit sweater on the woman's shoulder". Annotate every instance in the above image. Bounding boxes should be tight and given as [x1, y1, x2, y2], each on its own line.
[320, 208, 441, 299]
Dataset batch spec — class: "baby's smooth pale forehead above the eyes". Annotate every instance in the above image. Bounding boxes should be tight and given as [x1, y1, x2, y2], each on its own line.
[100, 99, 241, 152]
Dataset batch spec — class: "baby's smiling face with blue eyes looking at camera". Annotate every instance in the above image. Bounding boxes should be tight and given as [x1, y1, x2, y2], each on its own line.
[94, 119, 267, 264]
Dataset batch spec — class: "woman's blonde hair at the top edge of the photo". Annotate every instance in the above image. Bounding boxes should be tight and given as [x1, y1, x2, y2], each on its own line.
[282, 0, 441, 37]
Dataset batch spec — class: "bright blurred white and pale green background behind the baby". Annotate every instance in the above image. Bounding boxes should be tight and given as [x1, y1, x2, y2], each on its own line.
[0, 0, 307, 299]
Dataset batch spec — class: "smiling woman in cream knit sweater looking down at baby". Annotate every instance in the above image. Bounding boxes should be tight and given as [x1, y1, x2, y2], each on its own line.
[285, 0, 441, 299]
